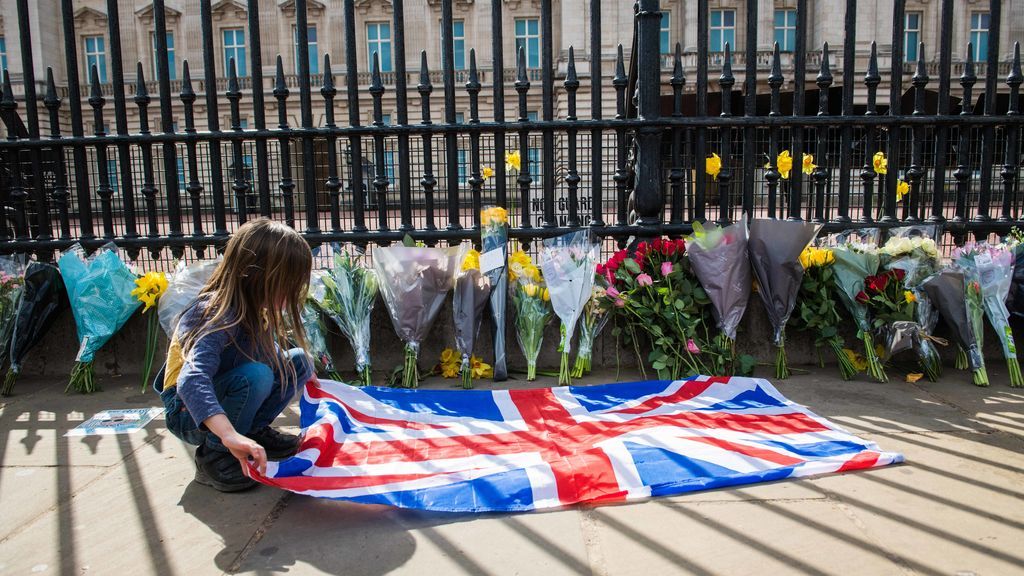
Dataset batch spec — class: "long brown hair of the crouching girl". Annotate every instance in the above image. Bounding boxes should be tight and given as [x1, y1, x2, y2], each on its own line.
[181, 218, 312, 386]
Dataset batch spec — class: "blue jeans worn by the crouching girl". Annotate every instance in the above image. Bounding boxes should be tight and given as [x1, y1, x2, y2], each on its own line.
[161, 348, 313, 452]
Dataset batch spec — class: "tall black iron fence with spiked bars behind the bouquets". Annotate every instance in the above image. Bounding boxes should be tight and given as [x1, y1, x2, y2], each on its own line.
[0, 0, 1024, 260]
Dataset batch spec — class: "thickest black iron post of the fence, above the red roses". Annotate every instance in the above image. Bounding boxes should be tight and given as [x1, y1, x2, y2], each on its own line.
[634, 0, 665, 228]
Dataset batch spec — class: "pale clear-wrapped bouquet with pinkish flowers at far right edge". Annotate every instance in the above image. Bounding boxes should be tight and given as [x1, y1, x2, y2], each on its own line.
[952, 244, 1024, 387]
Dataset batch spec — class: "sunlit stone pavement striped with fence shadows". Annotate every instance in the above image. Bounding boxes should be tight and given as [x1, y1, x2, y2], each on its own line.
[0, 363, 1024, 576]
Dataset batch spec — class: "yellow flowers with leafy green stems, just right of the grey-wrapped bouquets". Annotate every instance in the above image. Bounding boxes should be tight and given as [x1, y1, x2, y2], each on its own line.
[793, 246, 857, 380]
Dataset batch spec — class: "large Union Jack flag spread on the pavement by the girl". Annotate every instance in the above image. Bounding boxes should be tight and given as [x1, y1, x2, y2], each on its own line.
[248, 376, 903, 511]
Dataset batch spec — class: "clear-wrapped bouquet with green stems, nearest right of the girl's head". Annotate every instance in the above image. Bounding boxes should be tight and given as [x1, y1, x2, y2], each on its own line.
[313, 248, 380, 385]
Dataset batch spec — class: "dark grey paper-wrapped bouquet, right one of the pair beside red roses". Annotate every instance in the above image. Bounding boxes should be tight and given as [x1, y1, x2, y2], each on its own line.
[749, 220, 821, 379]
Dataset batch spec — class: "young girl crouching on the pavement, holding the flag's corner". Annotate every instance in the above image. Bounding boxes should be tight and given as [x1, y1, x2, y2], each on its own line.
[155, 219, 314, 492]
